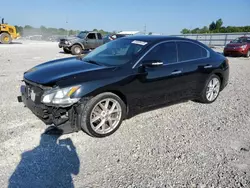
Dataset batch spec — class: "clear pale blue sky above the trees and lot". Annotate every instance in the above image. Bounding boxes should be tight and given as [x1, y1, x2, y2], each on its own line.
[0, 0, 250, 34]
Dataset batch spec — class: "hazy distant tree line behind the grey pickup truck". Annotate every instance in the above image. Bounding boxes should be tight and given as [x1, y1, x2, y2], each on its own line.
[15, 25, 111, 37]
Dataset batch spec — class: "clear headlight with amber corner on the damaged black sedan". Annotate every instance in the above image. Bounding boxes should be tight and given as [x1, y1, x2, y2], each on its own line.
[41, 86, 81, 105]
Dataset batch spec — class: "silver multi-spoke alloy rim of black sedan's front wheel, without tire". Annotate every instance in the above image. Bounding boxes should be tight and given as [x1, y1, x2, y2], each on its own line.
[90, 98, 122, 134]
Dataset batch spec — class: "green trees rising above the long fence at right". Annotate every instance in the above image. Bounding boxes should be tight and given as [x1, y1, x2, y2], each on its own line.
[181, 19, 250, 34]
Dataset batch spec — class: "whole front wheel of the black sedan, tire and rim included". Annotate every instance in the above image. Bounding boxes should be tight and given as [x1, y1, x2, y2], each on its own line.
[81, 92, 126, 138]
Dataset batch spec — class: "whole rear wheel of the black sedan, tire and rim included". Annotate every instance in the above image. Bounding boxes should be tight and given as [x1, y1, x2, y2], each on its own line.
[197, 74, 221, 104]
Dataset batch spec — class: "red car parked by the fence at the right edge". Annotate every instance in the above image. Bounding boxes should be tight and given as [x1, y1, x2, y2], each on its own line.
[224, 36, 250, 57]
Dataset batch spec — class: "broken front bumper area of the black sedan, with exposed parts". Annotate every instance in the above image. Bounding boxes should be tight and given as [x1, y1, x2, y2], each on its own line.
[17, 85, 80, 134]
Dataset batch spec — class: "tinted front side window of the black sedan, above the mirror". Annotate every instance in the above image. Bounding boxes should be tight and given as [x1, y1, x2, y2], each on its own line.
[144, 42, 177, 64]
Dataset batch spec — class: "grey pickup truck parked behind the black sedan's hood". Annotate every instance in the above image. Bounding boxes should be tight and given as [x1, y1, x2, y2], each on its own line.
[58, 31, 104, 55]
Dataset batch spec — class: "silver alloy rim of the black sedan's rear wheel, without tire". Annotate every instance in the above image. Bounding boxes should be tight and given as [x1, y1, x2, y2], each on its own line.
[206, 78, 220, 102]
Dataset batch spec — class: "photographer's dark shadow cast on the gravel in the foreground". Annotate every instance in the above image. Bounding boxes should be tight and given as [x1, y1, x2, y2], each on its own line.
[8, 134, 80, 188]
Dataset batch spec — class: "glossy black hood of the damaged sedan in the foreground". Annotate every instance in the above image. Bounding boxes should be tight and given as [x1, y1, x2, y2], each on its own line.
[24, 57, 111, 85]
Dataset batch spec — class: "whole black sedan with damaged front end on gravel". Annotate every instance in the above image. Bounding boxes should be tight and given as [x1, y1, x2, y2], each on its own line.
[18, 36, 229, 137]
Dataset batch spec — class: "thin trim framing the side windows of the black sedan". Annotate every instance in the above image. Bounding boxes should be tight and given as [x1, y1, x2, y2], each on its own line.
[132, 40, 210, 69]
